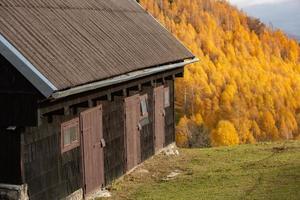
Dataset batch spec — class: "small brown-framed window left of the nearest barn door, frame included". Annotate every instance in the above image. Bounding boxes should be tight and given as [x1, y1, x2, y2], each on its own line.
[61, 118, 80, 153]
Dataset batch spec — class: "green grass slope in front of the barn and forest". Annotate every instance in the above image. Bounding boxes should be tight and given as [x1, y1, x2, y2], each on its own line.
[103, 141, 300, 200]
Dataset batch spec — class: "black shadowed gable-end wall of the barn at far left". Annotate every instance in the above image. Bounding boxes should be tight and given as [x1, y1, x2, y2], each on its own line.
[0, 53, 37, 199]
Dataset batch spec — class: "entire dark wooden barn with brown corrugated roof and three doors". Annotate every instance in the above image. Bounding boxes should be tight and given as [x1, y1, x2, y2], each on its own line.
[0, 0, 197, 200]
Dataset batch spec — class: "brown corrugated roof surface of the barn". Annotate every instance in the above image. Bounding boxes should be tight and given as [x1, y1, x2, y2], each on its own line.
[0, 0, 194, 90]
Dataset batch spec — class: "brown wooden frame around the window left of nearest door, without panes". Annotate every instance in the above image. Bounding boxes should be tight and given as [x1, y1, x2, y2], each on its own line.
[60, 117, 80, 154]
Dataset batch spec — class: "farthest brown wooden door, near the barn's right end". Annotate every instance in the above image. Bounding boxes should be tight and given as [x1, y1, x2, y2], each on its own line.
[154, 86, 165, 152]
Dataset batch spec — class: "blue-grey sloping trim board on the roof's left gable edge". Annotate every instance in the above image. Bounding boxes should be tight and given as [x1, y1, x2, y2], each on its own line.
[0, 34, 58, 97]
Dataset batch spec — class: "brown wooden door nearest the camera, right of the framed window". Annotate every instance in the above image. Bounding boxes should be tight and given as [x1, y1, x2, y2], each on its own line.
[81, 106, 104, 194]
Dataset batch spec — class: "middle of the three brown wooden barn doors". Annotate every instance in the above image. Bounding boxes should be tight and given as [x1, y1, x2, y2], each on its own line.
[125, 95, 141, 171]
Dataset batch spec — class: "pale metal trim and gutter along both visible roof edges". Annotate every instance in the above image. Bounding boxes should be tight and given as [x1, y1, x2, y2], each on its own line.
[0, 34, 199, 100]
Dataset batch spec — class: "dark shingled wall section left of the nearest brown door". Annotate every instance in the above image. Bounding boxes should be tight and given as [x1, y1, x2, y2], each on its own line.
[23, 116, 82, 200]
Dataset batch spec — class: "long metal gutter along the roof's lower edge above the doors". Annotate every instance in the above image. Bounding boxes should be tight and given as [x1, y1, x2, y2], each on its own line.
[51, 57, 199, 99]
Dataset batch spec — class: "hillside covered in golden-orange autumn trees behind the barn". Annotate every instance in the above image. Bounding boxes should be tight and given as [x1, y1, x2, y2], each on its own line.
[140, 0, 300, 146]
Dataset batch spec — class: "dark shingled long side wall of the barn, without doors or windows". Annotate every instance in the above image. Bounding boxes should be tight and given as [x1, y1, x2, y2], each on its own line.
[5, 68, 182, 200]
